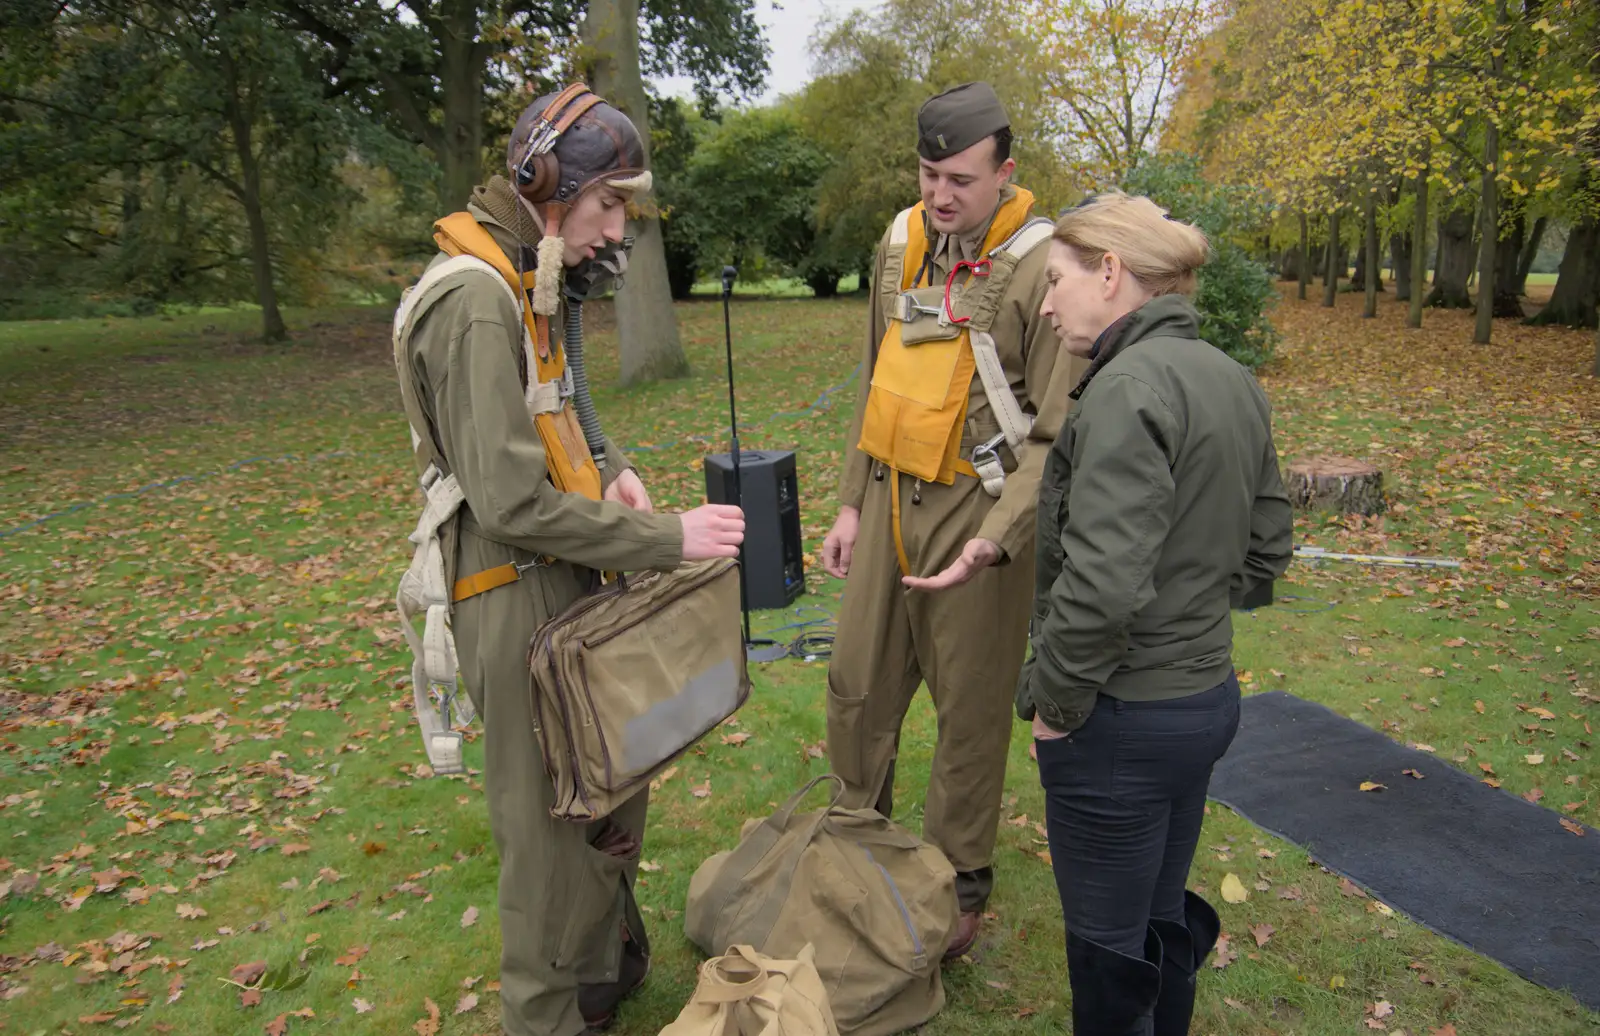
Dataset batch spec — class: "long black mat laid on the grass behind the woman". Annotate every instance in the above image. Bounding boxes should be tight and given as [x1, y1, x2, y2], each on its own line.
[1210, 691, 1600, 1010]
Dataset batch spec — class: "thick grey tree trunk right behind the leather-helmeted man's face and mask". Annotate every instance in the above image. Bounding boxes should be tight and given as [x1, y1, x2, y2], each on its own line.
[582, 0, 690, 385]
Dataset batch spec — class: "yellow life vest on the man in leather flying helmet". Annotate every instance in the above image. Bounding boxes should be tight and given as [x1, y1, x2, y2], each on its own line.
[434, 213, 600, 500]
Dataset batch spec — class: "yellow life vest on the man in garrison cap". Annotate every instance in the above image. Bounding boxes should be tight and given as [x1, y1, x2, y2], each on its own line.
[858, 187, 1048, 489]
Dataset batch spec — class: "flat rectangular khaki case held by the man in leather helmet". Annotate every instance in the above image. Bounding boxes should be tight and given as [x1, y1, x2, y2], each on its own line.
[528, 558, 750, 822]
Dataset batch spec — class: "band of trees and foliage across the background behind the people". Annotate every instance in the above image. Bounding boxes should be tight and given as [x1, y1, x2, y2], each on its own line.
[0, 0, 1600, 372]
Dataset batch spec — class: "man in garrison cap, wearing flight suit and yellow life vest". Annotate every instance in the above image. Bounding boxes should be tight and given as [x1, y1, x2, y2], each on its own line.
[822, 83, 1085, 961]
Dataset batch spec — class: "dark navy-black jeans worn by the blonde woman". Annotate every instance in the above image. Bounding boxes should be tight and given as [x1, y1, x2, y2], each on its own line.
[1038, 675, 1238, 958]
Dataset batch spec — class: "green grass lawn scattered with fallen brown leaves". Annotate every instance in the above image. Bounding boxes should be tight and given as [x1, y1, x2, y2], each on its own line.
[0, 284, 1600, 1036]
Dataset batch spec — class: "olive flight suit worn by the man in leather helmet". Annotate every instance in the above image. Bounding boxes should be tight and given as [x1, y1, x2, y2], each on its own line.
[402, 208, 683, 1036]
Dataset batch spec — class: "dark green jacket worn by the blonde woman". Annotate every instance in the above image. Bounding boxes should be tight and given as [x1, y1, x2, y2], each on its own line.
[1018, 294, 1294, 731]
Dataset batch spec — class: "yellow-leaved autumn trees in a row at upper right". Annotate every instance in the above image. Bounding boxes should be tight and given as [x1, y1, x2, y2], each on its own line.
[1163, 0, 1600, 342]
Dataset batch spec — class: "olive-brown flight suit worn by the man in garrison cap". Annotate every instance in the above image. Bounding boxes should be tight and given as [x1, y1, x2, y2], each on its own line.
[827, 187, 1088, 911]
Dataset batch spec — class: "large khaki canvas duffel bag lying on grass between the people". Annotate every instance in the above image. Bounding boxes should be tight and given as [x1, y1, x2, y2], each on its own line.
[683, 774, 960, 1036]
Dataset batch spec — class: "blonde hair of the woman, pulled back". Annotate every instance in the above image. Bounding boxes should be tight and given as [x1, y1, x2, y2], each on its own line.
[1051, 190, 1211, 296]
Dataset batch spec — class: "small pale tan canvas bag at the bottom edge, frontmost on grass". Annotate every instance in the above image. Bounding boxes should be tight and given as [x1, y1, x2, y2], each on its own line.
[661, 946, 838, 1036]
